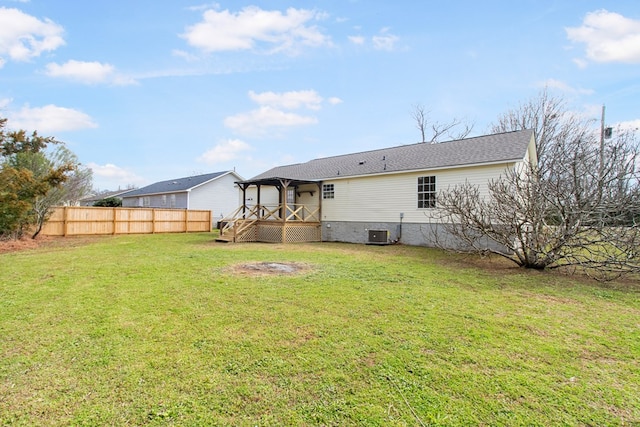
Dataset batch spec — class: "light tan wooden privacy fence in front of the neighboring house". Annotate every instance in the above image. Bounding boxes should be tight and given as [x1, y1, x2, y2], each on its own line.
[41, 206, 211, 236]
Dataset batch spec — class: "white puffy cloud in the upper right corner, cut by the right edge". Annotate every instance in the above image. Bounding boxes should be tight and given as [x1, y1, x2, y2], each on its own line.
[565, 9, 640, 65]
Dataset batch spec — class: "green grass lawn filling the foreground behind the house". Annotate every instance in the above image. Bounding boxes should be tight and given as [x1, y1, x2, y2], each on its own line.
[0, 233, 640, 426]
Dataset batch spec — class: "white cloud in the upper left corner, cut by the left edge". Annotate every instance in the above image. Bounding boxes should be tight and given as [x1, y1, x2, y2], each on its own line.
[0, 7, 64, 67]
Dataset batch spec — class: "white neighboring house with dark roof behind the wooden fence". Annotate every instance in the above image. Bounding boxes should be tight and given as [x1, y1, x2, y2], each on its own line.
[122, 171, 242, 219]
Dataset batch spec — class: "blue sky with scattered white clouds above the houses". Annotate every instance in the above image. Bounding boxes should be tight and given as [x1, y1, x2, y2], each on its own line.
[0, 0, 640, 190]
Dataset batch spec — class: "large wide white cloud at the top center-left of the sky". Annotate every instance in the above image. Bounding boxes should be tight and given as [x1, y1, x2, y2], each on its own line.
[181, 6, 330, 54]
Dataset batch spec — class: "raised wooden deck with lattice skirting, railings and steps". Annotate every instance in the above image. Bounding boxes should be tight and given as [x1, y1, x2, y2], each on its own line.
[216, 205, 322, 243]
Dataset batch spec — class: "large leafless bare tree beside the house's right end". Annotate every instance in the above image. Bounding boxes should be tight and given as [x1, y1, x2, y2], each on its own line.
[438, 91, 640, 277]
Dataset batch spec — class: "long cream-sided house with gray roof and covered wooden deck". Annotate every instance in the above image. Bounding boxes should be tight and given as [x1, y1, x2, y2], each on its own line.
[221, 130, 537, 246]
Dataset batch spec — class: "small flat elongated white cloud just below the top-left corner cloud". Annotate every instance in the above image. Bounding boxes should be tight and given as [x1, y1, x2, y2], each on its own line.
[45, 60, 136, 86]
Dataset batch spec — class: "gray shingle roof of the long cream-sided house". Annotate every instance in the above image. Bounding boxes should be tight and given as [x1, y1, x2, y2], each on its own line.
[247, 130, 533, 182]
